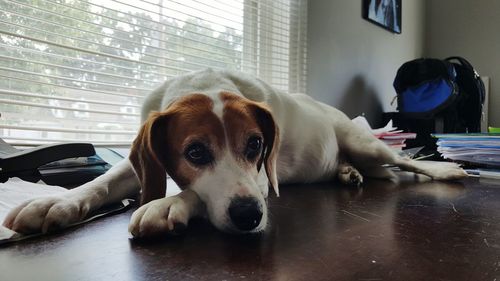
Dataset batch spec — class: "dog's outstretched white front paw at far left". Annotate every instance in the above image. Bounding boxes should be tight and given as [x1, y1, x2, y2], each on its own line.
[3, 196, 89, 234]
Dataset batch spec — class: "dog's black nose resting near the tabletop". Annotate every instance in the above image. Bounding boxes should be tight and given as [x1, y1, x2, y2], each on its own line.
[229, 197, 262, 231]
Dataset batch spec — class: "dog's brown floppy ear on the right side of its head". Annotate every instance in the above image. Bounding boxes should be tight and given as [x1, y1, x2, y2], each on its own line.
[250, 103, 280, 197]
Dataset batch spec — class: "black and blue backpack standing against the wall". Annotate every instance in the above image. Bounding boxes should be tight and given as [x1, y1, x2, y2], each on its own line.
[393, 57, 485, 133]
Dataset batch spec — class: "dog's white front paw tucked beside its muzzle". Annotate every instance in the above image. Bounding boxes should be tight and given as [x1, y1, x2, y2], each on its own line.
[128, 196, 190, 238]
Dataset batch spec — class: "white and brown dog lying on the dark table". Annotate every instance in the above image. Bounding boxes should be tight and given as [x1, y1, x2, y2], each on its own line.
[3, 69, 467, 237]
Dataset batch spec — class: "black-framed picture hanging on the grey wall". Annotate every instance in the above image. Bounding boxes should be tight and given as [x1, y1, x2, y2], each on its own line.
[362, 0, 401, 33]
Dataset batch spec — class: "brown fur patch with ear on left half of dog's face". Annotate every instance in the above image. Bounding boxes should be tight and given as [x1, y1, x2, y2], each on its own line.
[130, 94, 225, 204]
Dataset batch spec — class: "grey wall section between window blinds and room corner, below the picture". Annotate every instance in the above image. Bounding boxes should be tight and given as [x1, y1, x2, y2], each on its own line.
[307, 0, 424, 125]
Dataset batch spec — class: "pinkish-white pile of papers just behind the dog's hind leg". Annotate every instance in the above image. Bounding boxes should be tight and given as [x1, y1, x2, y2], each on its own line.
[352, 116, 417, 150]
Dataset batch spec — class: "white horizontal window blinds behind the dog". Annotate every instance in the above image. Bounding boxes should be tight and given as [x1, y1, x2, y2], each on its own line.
[0, 0, 307, 145]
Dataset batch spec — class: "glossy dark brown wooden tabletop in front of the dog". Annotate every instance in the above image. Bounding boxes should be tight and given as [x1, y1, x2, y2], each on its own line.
[0, 176, 500, 281]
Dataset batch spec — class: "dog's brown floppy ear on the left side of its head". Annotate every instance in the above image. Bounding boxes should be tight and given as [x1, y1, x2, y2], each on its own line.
[129, 112, 169, 205]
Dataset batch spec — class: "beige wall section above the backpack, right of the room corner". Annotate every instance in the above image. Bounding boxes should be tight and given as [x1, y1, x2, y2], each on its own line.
[426, 0, 500, 127]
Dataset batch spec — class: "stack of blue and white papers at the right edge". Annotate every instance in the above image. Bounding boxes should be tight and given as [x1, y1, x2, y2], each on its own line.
[433, 133, 500, 167]
